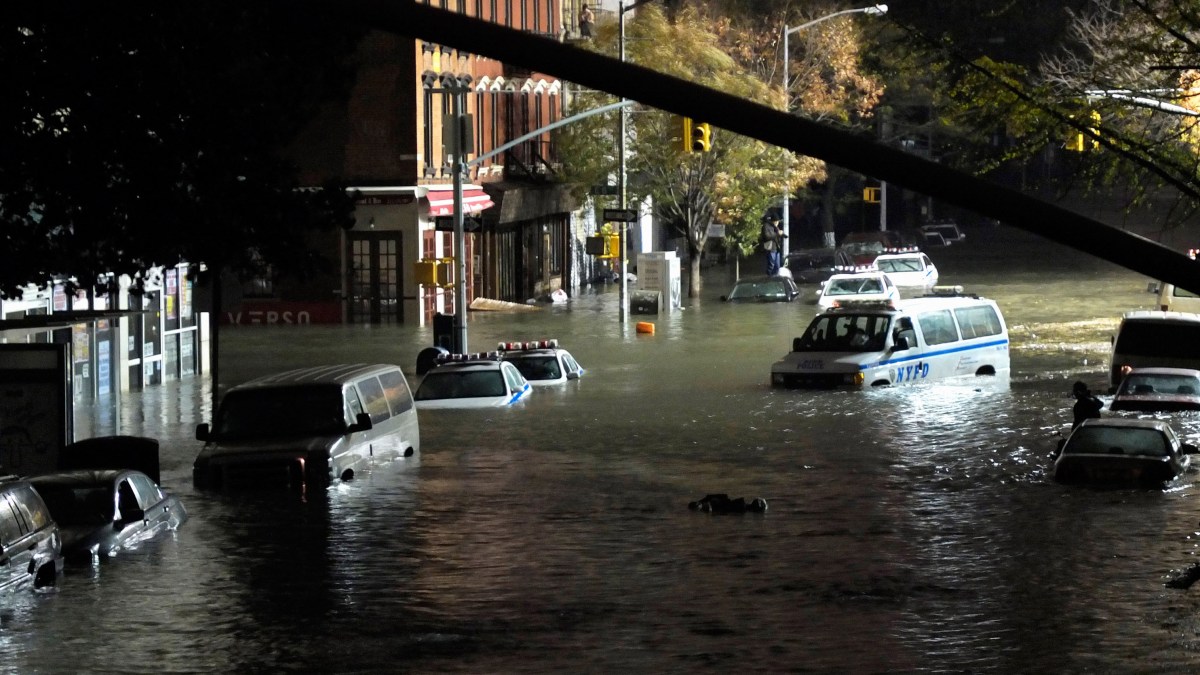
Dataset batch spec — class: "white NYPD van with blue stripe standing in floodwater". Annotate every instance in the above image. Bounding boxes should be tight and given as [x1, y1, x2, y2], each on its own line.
[770, 286, 1009, 389]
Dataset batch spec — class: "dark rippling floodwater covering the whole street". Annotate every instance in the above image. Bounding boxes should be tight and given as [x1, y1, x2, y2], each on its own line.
[7, 227, 1200, 674]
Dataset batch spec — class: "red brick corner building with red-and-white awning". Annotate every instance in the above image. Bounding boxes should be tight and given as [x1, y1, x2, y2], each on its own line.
[259, 0, 594, 324]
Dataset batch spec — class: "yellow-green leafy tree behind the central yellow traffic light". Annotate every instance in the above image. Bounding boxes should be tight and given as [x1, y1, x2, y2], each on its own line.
[557, 5, 821, 297]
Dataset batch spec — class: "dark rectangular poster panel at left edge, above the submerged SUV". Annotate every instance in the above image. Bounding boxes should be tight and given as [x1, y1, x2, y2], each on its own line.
[0, 344, 74, 476]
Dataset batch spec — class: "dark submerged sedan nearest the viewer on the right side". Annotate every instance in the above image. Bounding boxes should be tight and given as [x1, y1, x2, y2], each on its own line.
[1054, 418, 1196, 486]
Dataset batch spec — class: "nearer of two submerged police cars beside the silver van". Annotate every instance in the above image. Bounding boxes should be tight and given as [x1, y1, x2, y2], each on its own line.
[413, 352, 533, 410]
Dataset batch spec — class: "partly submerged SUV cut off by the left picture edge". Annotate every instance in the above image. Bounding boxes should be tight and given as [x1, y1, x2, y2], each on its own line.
[0, 478, 62, 592]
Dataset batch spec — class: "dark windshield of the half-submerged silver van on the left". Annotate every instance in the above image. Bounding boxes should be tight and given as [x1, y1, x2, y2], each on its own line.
[215, 384, 346, 440]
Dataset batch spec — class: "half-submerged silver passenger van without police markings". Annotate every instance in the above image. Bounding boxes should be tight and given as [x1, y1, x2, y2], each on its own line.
[192, 364, 420, 489]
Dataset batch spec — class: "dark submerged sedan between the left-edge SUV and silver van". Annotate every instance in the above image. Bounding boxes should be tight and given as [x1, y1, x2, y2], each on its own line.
[29, 468, 187, 562]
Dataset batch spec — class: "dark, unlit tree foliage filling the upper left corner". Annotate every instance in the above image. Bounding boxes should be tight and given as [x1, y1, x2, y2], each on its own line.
[0, 0, 358, 295]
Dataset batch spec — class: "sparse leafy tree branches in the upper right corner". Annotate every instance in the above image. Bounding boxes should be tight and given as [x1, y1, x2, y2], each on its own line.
[1039, 0, 1200, 216]
